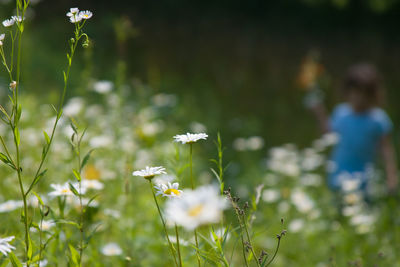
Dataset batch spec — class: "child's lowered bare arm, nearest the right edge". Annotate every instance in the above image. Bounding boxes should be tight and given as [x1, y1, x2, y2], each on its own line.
[380, 135, 398, 192]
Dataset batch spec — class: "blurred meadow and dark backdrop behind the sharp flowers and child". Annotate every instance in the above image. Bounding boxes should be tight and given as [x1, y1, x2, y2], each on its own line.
[0, 0, 400, 267]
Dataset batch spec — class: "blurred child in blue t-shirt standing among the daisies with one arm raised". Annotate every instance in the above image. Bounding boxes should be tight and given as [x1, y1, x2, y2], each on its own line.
[308, 64, 397, 196]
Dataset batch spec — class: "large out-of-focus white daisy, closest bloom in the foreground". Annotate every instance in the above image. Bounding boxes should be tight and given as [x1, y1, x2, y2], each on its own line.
[165, 185, 227, 230]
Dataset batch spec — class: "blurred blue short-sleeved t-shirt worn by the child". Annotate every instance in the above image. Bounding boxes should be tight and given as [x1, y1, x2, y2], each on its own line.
[329, 103, 393, 189]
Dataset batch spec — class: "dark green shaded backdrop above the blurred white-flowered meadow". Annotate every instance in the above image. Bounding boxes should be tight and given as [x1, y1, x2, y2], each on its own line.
[0, 0, 400, 150]
